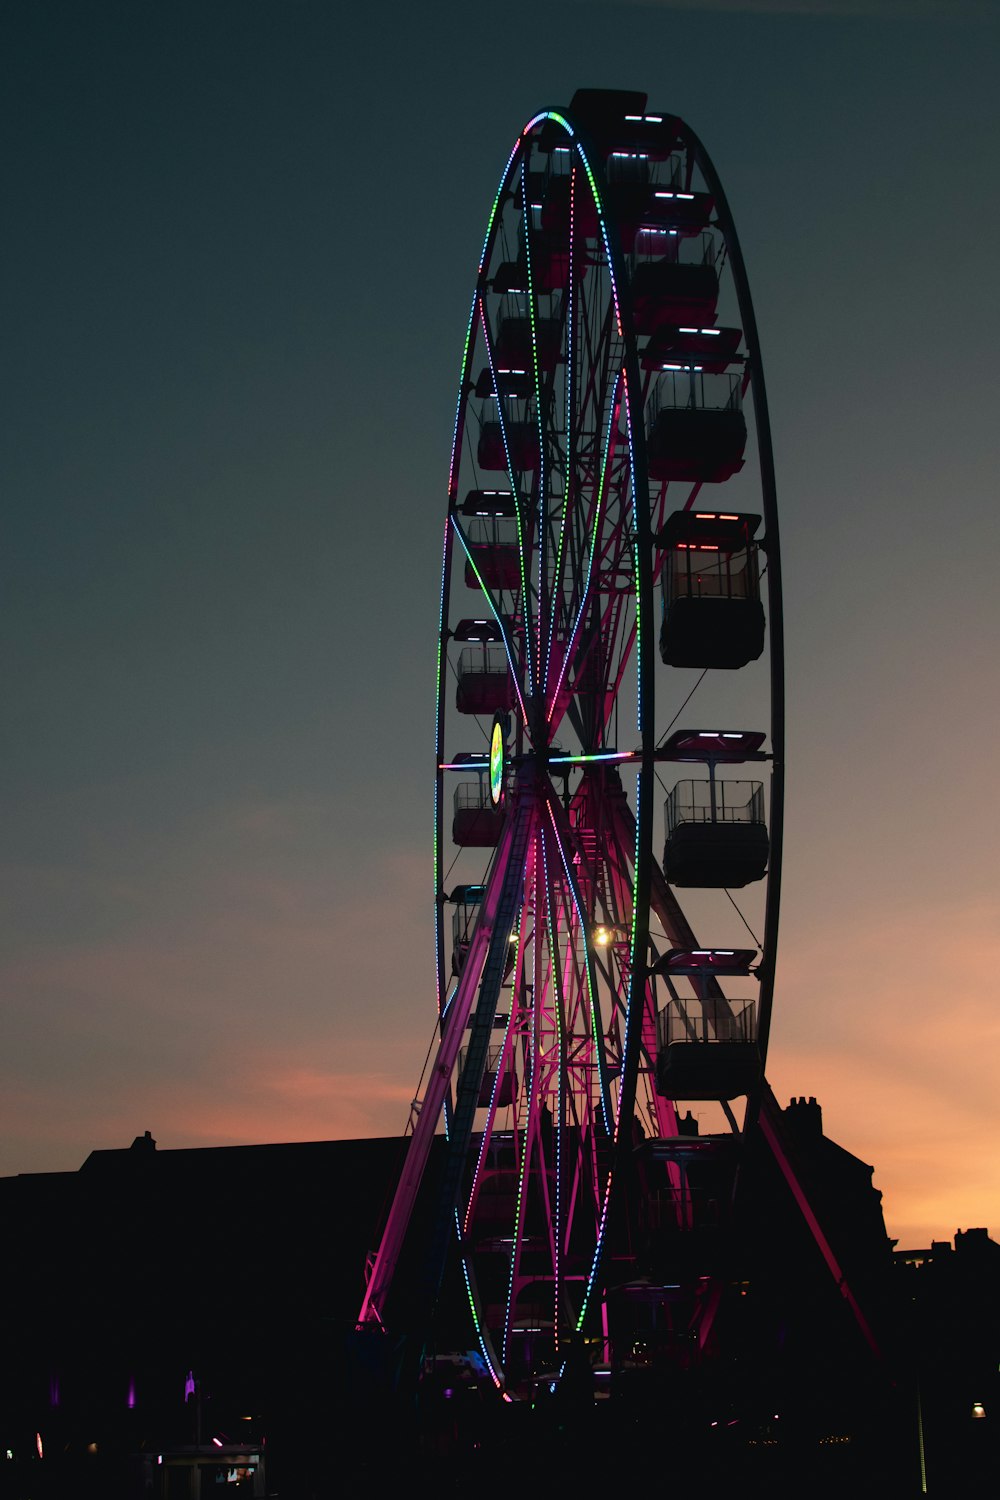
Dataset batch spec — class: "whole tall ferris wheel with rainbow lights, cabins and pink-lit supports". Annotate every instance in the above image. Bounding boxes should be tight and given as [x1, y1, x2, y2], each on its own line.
[358, 90, 783, 1398]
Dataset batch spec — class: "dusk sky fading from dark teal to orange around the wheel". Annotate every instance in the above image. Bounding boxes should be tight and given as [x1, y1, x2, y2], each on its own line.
[0, 0, 1000, 1245]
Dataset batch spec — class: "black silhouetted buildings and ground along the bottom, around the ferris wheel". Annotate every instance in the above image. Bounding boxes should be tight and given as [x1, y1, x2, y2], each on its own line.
[0, 1098, 1000, 1500]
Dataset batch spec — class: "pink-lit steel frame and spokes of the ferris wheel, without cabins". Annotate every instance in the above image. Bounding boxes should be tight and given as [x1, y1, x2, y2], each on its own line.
[360, 99, 783, 1394]
